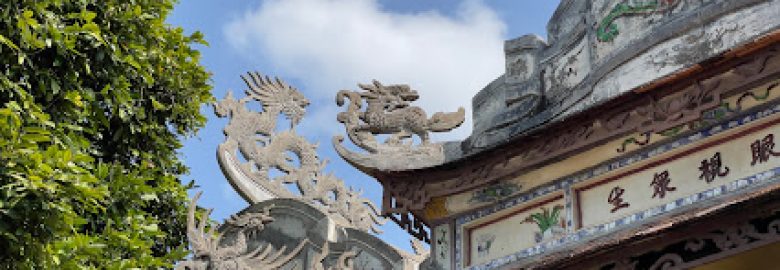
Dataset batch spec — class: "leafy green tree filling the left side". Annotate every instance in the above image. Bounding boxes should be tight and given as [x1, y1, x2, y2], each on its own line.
[0, 0, 213, 269]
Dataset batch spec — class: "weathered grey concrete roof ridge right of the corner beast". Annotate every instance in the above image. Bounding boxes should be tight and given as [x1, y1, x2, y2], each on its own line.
[445, 0, 780, 162]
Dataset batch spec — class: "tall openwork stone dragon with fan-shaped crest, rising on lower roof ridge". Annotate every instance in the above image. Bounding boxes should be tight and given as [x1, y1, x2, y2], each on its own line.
[214, 72, 386, 233]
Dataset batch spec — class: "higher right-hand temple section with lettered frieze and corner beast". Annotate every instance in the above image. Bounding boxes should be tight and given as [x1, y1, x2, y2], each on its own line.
[333, 0, 780, 269]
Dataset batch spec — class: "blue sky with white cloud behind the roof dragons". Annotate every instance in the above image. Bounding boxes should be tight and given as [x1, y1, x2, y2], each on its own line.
[168, 0, 559, 250]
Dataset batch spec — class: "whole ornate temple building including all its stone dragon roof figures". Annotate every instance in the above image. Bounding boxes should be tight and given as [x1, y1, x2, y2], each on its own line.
[178, 0, 780, 270]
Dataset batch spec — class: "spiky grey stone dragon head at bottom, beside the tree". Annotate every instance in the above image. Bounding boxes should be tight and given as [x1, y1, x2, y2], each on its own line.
[176, 192, 308, 270]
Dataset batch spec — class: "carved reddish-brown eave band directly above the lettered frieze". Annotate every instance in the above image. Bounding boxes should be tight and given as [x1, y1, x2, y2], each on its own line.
[376, 42, 780, 219]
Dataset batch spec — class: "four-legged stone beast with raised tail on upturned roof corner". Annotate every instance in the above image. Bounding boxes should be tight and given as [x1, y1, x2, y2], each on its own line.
[333, 80, 466, 171]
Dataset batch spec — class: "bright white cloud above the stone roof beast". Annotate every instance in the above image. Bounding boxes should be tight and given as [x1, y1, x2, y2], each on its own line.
[225, 0, 505, 139]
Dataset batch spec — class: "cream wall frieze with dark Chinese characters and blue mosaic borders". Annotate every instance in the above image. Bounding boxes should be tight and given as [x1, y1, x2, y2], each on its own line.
[450, 88, 780, 269]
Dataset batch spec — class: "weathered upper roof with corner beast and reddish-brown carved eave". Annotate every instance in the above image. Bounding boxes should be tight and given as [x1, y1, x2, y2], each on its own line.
[334, 0, 780, 235]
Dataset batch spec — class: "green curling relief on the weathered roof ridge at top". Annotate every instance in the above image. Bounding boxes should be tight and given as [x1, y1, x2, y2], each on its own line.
[596, 0, 682, 42]
